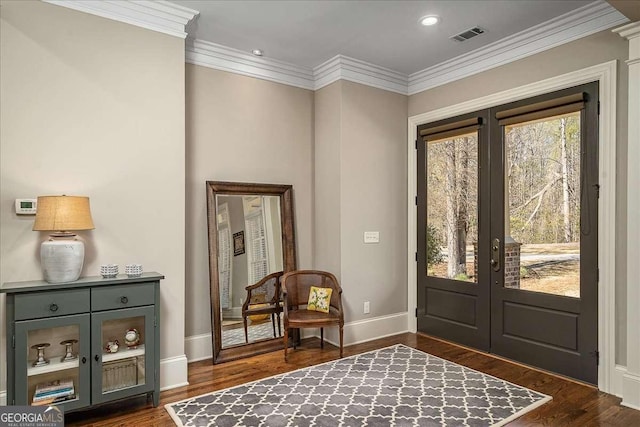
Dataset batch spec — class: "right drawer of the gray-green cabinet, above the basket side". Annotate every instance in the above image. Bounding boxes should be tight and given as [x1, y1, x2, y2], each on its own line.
[91, 283, 155, 311]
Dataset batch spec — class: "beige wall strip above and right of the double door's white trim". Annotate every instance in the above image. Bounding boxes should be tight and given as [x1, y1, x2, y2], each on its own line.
[409, 31, 629, 365]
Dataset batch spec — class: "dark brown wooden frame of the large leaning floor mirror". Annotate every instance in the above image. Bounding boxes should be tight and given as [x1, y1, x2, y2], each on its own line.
[206, 181, 296, 364]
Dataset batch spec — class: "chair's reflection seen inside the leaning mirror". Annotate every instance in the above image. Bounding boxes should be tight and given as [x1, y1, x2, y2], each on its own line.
[242, 271, 283, 343]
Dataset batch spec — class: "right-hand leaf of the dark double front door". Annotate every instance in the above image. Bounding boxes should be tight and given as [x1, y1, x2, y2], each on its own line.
[490, 83, 598, 384]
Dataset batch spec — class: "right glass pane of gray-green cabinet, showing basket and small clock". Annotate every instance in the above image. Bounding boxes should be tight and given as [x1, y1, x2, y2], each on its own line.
[102, 316, 146, 393]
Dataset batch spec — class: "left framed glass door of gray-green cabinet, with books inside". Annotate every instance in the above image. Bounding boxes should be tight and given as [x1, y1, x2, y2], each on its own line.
[15, 314, 91, 410]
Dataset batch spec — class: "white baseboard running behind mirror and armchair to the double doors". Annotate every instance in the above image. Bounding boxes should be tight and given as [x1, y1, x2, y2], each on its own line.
[184, 311, 408, 362]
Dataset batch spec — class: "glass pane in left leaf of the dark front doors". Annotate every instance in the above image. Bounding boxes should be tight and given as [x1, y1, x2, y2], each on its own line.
[426, 133, 478, 282]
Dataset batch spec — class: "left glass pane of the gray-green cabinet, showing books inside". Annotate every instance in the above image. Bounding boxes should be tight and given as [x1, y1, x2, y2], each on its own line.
[27, 325, 80, 406]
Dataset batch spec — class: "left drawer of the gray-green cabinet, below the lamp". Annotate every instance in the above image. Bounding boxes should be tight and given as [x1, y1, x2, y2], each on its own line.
[15, 289, 89, 320]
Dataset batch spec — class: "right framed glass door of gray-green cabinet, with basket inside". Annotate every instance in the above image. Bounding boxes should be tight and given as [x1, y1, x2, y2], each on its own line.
[91, 306, 155, 403]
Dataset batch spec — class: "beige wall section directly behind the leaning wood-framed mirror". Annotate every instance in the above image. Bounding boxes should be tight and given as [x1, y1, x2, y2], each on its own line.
[185, 64, 313, 336]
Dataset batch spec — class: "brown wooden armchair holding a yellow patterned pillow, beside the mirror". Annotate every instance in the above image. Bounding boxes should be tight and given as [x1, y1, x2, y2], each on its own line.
[281, 270, 344, 361]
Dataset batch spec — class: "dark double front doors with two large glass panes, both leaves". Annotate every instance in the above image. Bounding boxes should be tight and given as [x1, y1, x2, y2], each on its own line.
[417, 83, 599, 383]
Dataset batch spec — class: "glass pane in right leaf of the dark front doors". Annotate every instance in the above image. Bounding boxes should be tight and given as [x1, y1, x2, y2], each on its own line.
[504, 112, 581, 298]
